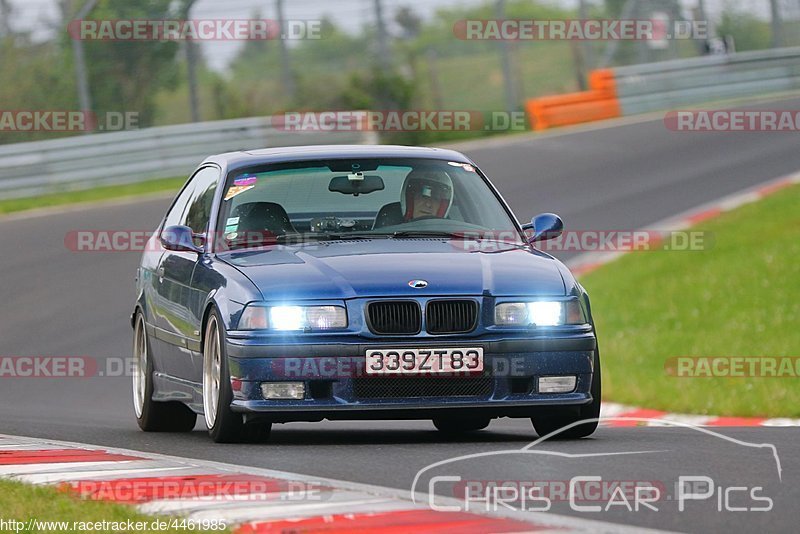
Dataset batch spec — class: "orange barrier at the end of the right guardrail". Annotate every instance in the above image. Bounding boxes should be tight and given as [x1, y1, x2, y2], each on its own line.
[525, 69, 622, 130]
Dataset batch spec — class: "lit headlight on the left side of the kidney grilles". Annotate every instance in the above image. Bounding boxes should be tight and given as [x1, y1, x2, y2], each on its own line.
[239, 305, 347, 330]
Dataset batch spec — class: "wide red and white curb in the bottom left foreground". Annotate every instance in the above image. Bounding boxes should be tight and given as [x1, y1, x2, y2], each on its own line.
[0, 435, 653, 534]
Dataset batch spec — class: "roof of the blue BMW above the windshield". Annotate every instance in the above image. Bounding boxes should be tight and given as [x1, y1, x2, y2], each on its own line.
[203, 145, 472, 170]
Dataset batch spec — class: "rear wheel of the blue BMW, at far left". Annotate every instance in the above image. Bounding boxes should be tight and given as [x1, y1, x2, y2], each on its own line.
[133, 311, 197, 432]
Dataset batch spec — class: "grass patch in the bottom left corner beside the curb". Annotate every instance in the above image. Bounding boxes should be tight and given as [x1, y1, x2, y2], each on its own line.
[0, 480, 230, 534]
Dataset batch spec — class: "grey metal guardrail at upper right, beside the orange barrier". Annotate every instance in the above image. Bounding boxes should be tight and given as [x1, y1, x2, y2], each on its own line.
[614, 48, 800, 115]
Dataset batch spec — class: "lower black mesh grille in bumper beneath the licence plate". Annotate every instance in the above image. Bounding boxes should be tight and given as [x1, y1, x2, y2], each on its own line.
[353, 376, 494, 399]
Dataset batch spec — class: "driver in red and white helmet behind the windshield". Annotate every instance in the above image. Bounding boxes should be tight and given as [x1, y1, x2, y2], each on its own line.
[400, 170, 453, 221]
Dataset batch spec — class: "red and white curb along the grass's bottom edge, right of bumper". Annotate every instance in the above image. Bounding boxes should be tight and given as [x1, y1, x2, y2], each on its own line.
[600, 402, 800, 427]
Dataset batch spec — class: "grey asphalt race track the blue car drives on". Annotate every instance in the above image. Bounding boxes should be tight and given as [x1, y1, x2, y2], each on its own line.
[0, 100, 800, 532]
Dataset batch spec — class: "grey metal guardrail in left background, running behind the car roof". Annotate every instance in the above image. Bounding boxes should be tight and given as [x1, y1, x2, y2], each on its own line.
[0, 117, 375, 198]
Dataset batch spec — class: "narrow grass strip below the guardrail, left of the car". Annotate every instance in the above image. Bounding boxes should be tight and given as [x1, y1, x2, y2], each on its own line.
[0, 177, 186, 214]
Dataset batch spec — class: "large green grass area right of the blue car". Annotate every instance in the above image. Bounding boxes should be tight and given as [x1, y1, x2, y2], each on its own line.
[581, 186, 800, 417]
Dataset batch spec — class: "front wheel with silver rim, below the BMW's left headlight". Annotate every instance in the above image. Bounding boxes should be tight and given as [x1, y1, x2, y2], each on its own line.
[203, 309, 272, 443]
